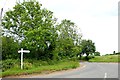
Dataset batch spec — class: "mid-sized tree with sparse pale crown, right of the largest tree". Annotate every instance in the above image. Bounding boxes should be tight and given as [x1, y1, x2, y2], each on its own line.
[56, 19, 81, 58]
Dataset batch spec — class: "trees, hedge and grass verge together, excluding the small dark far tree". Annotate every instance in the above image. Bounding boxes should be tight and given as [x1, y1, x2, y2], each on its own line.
[1, 0, 84, 77]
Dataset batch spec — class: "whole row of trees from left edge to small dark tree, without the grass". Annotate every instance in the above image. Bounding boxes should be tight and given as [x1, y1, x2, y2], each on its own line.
[2, 0, 95, 60]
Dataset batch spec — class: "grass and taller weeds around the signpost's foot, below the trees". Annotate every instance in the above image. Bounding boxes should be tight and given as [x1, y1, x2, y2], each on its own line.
[2, 60, 79, 77]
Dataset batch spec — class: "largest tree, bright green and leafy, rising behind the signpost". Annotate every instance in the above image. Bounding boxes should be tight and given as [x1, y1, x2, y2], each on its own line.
[2, 0, 57, 60]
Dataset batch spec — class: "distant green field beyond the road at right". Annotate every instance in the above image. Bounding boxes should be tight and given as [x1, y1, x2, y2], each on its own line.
[89, 55, 120, 62]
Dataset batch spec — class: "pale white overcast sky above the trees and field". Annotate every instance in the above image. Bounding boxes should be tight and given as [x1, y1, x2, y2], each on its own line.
[0, 0, 120, 55]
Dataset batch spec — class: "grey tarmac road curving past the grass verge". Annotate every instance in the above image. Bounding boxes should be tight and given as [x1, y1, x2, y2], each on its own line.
[31, 62, 118, 78]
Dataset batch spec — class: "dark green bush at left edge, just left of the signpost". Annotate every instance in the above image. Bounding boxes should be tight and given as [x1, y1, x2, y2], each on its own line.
[2, 36, 19, 60]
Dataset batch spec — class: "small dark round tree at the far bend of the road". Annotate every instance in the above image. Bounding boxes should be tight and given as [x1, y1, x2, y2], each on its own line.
[80, 40, 96, 60]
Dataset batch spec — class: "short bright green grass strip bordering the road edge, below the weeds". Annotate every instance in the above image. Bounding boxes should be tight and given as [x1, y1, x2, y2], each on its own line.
[2, 61, 79, 77]
